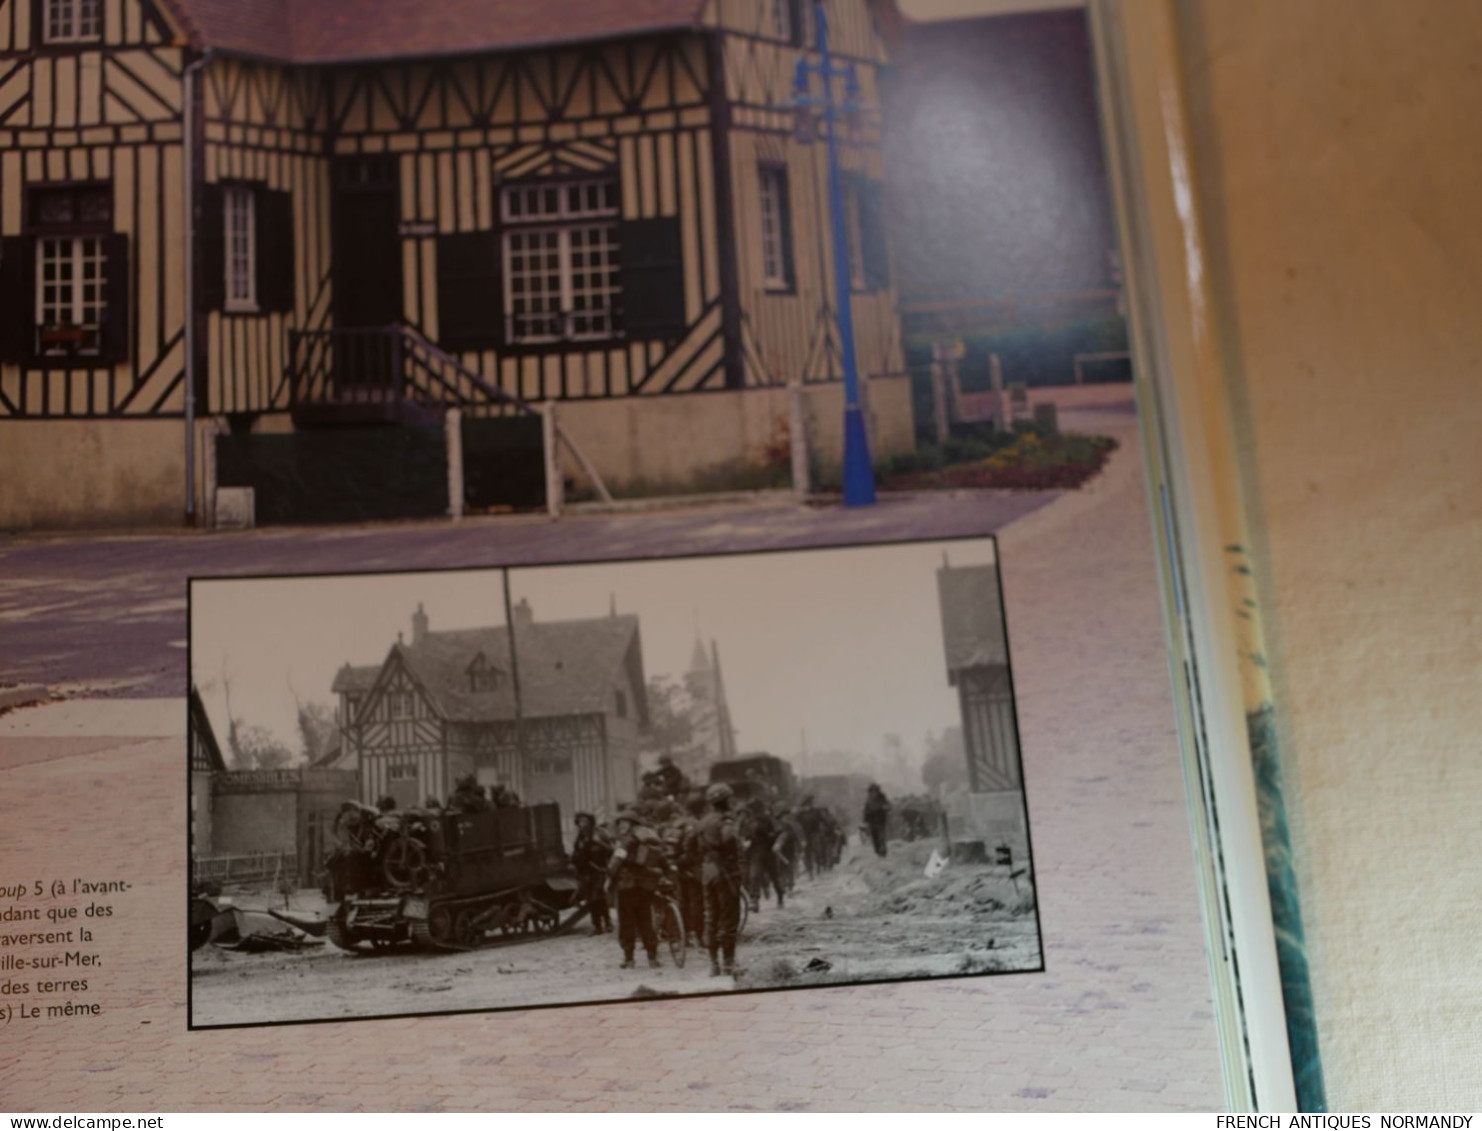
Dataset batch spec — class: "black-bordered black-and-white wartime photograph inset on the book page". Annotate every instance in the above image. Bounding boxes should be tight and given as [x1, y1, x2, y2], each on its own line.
[190, 538, 1042, 1027]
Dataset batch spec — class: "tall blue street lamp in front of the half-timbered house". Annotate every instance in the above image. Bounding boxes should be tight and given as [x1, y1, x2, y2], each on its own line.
[793, 3, 874, 507]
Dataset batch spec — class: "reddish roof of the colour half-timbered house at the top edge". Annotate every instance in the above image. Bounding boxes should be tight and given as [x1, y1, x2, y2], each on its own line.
[163, 0, 702, 62]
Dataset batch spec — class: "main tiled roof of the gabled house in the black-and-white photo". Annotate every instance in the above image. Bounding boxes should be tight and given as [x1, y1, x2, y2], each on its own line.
[391, 615, 646, 722]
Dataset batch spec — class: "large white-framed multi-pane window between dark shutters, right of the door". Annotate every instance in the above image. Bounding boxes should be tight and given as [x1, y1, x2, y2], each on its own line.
[499, 179, 621, 344]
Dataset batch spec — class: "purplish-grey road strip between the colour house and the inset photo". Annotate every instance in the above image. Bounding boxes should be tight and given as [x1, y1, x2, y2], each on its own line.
[0, 491, 1061, 697]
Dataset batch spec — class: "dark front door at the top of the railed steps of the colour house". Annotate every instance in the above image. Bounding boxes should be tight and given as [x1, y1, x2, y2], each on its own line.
[332, 154, 402, 397]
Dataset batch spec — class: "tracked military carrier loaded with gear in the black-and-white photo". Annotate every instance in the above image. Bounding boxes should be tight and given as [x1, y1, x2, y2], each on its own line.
[329, 805, 582, 950]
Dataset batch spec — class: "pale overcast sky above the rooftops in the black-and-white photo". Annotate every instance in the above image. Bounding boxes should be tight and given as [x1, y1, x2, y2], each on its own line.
[191, 540, 993, 756]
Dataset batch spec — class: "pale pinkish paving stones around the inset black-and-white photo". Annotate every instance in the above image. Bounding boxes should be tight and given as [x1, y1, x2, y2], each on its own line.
[0, 394, 1223, 1112]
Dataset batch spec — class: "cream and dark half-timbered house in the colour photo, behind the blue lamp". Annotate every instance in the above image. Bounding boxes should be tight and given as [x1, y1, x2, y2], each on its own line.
[0, 0, 913, 526]
